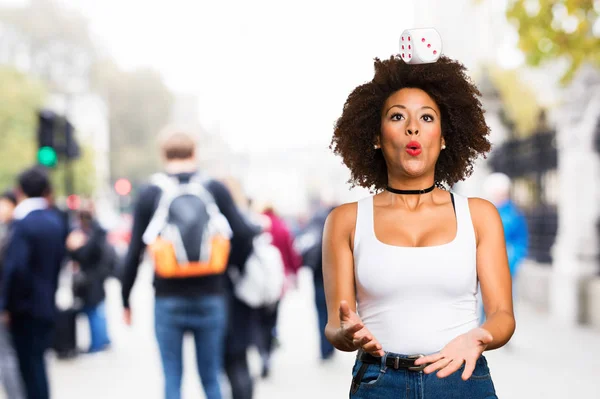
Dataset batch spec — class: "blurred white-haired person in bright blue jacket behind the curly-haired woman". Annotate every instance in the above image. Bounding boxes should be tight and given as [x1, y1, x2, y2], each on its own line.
[481, 173, 529, 322]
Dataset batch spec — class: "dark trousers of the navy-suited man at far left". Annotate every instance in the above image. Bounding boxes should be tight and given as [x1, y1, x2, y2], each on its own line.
[10, 316, 53, 399]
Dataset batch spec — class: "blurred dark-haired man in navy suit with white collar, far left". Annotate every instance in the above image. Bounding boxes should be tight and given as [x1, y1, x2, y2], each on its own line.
[0, 167, 67, 399]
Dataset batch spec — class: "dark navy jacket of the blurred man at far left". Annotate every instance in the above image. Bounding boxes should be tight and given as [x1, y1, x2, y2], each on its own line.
[0, 209, 67, 321]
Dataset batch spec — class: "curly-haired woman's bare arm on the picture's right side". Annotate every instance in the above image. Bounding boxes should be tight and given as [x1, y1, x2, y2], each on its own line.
[469, 198, 515, 350]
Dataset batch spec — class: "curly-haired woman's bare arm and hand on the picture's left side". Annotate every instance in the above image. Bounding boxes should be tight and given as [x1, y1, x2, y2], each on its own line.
[323, 203, 383, 356]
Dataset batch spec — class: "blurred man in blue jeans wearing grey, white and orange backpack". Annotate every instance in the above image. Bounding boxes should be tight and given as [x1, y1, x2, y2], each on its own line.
[122, 130, 256, 399]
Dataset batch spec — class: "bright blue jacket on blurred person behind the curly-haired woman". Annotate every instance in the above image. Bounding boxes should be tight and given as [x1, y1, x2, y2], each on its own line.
[498, 201, 529, 276]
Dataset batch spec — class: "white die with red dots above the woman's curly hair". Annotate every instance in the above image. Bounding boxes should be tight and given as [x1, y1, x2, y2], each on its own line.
[400, 28, 442, 64]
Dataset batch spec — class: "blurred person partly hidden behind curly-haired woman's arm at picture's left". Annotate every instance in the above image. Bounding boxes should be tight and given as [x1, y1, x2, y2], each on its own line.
[295, 202, 334, 360]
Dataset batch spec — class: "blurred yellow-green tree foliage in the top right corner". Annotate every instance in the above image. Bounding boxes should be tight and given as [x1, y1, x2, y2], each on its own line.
[506, 0, 600, 83]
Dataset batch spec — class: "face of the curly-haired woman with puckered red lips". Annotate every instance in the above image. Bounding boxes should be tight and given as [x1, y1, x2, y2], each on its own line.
[376, 88, 444, 177]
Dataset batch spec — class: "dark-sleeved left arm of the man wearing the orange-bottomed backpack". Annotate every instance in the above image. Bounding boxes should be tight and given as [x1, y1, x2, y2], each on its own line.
[121, 186, 160, 309]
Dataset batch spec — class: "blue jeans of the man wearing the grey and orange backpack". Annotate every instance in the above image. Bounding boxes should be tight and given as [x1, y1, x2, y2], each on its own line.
[154, 295, 227, 399]
